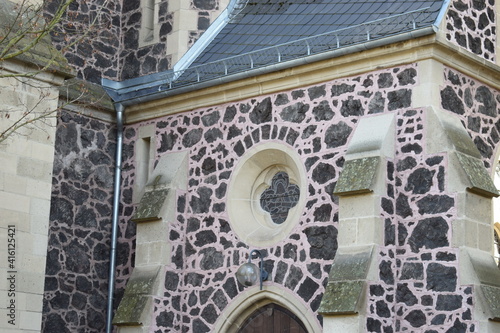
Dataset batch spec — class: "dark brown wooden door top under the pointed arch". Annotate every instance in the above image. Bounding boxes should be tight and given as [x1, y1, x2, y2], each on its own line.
[238, 303, 307, 333]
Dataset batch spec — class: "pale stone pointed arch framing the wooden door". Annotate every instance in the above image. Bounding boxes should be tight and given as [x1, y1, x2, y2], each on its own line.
[214, 286, 323, 333]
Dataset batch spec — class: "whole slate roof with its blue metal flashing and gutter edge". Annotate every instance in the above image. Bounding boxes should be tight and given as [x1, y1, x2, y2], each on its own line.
[103, 0, 448, 104]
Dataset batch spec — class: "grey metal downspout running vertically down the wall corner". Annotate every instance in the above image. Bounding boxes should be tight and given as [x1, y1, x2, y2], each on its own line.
[106, 103, 125, 333]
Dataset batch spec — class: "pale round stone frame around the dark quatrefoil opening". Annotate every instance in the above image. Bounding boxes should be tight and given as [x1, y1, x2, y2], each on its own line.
[227, 142, 307, 247]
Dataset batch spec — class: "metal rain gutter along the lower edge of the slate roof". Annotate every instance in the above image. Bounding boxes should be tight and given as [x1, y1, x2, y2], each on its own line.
[102, 25, 438, 106]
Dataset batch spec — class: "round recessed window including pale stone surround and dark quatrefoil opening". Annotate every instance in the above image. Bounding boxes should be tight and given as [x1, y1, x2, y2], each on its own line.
[227, 142, 307, 246]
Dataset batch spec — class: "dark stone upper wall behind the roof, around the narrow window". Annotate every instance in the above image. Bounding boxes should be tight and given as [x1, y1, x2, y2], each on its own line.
[47, 0, 223, 84]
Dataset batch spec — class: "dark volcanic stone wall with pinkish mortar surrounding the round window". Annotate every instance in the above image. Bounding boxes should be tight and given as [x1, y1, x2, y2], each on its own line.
[118, 65, 417, 332]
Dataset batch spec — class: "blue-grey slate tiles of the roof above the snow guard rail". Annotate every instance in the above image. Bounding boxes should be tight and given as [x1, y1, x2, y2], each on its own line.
[193, 0, 443, 66]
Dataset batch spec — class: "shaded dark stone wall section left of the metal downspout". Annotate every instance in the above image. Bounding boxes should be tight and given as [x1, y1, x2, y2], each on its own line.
[42, 112, 118, 332]
